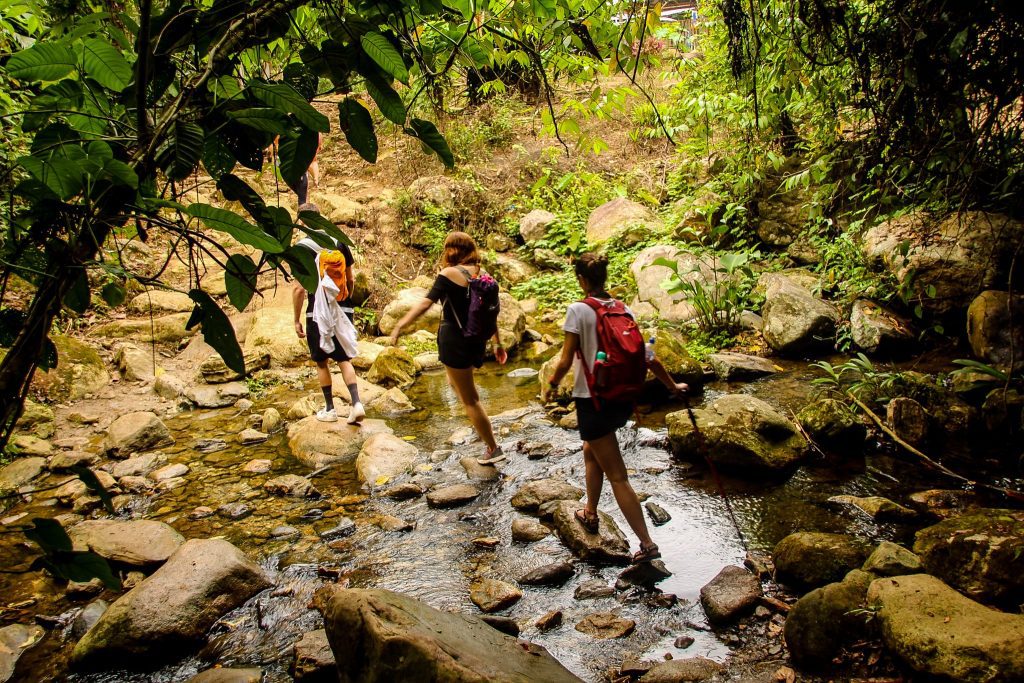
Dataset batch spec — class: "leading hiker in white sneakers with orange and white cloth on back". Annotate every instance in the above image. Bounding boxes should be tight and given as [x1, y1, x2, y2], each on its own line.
[292, 214, 367, 425]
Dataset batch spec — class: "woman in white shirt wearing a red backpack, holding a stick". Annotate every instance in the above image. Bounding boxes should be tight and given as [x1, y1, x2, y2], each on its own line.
[543, 253, 689, 563]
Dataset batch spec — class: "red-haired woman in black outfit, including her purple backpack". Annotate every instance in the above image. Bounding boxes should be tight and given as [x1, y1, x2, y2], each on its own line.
[391, 231, 508, 465]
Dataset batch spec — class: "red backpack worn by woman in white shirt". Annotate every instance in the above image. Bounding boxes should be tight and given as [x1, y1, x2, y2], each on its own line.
[577, 297, 647, 401]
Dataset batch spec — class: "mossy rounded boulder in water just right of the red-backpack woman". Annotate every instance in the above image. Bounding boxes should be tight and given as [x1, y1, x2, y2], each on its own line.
[665, 394, 807, 476]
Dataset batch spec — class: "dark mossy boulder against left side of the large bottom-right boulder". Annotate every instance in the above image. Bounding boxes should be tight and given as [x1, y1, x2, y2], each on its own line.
[782, 569, 874, 669]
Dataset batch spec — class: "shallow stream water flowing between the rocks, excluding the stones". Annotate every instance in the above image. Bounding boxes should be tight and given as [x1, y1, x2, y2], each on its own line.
[0, 356, 948, 683]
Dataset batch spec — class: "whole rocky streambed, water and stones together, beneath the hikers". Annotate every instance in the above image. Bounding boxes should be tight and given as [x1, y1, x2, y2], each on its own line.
[0, 352, 1021, 681]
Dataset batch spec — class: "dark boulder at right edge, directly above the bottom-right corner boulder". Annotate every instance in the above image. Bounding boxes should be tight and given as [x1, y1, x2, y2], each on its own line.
[913, 508, 1024, 607]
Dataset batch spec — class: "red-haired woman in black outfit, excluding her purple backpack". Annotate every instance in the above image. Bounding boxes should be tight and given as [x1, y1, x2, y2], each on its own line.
[391, 232, 508, 465]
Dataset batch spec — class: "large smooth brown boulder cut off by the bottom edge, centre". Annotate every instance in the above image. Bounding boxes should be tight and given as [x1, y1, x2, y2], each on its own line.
[323, 587, 580, 683]
